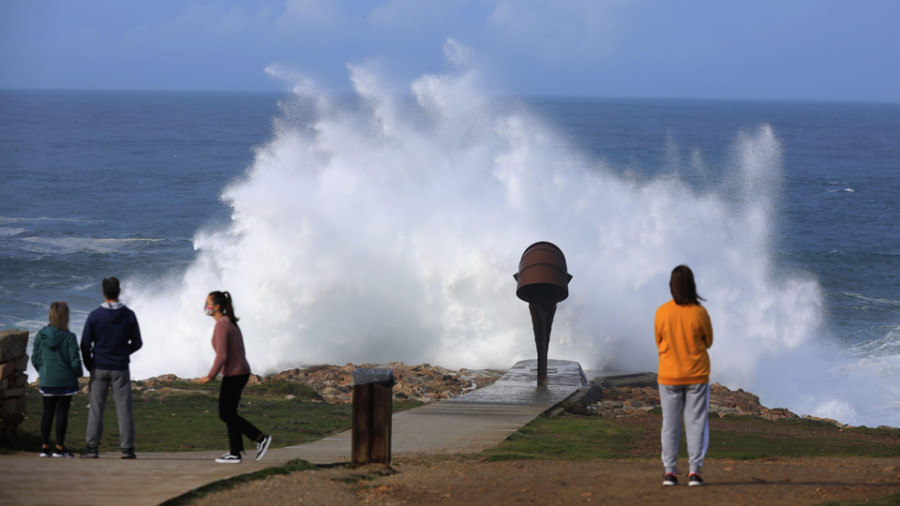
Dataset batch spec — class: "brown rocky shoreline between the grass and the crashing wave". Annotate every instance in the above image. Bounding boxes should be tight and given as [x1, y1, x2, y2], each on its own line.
[52, 362, 876, 428]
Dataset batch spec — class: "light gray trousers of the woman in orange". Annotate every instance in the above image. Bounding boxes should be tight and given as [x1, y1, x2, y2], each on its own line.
[659, 383, 709, 473]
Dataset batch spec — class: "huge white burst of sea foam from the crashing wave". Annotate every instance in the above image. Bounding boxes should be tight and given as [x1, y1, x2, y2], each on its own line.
[131, 47, 900, 425]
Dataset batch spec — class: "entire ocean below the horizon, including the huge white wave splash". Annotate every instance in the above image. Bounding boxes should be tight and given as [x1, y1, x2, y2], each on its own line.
[0, 81, 900, 427]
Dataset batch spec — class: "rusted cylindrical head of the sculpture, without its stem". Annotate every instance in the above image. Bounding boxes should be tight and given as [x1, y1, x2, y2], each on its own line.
[515, 242, 572, 305]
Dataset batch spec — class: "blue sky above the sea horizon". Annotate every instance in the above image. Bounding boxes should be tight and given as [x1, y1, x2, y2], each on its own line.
[0, 0, 900, 102]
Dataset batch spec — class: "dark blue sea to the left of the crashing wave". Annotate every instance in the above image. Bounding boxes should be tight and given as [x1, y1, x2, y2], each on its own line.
[0, 91, 279, 320]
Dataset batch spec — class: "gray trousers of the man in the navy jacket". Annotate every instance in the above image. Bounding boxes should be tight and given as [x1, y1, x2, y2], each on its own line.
[85, 369, 134, 450]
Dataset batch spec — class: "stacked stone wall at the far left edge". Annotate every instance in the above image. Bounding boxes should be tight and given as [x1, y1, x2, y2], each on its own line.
[0, 330, 28, 437]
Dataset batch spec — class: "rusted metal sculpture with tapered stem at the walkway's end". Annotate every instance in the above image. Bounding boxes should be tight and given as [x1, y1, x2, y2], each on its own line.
[513, 242, 572, 385]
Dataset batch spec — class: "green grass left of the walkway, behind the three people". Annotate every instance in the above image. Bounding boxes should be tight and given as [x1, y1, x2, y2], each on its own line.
[0, 381, 421, 453]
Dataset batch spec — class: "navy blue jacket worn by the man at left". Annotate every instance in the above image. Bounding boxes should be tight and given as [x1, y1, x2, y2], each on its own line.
[81, 303, 144, 371]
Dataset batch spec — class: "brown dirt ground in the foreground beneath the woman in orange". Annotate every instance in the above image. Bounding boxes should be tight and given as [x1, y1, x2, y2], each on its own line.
[185, 457, 900, 506]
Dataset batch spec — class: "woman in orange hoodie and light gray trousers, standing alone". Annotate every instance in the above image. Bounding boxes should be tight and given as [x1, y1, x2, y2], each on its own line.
[654, 265, 713, 486]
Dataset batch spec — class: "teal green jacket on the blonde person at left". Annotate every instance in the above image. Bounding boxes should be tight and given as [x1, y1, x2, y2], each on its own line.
[31, 325, 84, 388]
